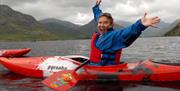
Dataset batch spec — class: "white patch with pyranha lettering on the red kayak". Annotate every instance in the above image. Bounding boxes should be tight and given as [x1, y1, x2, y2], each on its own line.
[37, 57, 77, 77]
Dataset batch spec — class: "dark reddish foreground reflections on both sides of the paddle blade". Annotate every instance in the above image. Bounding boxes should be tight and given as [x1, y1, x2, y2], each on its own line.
[0, 71, 180, 91]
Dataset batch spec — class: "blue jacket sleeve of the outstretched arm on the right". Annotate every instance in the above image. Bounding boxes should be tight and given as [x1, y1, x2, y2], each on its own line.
[114, 20, 147, 48]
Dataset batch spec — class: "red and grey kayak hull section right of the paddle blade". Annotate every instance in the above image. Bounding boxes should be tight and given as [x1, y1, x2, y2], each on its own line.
[78, 60, 180, 82]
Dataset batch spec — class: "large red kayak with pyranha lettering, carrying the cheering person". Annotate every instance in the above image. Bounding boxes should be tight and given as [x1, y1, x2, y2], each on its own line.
[0, 56, 180, 81]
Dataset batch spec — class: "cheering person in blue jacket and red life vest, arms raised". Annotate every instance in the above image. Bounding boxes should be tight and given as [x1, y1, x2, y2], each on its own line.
[89, 0, 160, 66]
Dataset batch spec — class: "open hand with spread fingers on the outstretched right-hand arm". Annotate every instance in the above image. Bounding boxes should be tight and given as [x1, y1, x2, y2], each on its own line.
[141, 13, 160, 28]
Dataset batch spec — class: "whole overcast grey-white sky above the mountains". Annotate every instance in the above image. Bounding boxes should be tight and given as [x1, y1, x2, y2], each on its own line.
[0, 0, 180, 25]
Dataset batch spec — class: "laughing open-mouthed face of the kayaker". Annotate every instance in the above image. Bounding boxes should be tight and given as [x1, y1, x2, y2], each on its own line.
[98, 16, 113, 34]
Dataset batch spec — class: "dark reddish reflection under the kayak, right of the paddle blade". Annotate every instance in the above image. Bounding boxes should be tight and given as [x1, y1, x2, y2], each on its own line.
[72, 81, 180, 91]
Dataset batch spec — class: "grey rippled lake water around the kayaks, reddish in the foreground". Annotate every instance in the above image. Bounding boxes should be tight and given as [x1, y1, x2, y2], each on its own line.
[0, 37, 180, 91]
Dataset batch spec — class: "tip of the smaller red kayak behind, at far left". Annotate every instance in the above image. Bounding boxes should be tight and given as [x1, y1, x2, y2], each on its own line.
[0, 48, 31, 57]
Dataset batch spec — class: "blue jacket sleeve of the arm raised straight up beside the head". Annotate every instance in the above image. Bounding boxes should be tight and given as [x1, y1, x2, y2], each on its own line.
[93, 4, 102, 23]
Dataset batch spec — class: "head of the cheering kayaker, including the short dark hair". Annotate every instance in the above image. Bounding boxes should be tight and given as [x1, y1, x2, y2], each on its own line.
[98, 13, 114, 34]
